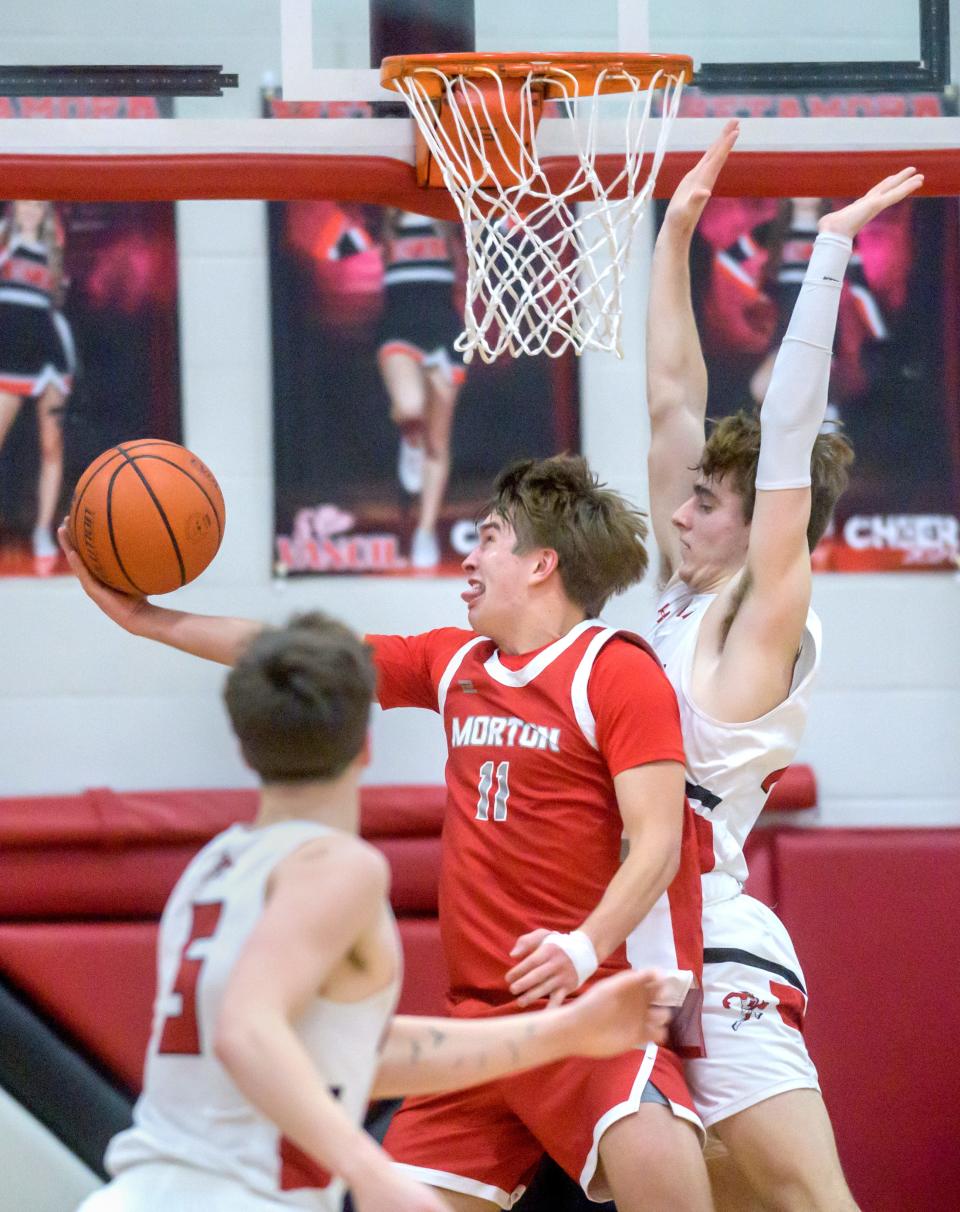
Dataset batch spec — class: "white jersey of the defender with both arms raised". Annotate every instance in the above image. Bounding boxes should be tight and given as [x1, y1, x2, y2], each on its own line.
[647, 581, 821, 884]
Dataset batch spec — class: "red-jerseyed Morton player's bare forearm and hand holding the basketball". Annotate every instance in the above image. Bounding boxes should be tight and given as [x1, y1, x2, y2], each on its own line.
[57, 525, 263, 665]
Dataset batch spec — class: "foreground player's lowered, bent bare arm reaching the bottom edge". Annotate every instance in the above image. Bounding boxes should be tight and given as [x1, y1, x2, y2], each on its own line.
[215, 839, 446, 1212]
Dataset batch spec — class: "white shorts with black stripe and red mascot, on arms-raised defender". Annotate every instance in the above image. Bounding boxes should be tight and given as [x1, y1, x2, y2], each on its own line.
[684, 876, 819, 1128]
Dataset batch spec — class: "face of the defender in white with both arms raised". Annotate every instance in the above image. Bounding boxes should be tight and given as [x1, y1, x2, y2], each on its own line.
[670, 478, 750, 593]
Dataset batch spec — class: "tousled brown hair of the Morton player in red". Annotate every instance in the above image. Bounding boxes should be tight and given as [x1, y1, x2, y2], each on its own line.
[482, 455, 647, 617]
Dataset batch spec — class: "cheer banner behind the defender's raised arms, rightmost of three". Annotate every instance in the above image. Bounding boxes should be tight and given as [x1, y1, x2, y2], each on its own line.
[673, 198, 960, 572]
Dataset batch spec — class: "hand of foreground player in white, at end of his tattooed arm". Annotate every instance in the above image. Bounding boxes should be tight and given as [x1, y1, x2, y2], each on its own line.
[564, 970, 670, 1057]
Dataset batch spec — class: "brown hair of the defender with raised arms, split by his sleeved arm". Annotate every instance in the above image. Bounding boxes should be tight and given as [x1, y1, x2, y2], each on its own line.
[695, 410, 853, 551]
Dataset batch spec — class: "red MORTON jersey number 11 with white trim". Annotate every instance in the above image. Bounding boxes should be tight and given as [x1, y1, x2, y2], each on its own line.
[367, 619, 702, 1012]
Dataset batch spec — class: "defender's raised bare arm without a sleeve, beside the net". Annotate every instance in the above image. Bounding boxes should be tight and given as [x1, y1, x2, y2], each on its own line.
[646, 121, 739, 581]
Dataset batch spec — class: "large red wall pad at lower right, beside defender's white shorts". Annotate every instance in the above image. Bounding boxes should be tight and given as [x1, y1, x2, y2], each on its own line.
[773, 829, 960, 1212]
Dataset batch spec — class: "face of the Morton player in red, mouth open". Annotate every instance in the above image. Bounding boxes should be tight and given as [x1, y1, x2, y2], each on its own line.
[461, 514, 537, 645]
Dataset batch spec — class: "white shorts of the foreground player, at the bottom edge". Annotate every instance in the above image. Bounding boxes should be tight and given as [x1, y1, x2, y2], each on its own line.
[76, 1161, 343, 1212]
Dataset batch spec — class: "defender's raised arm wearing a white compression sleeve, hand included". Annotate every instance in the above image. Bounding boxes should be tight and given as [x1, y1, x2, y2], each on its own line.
[716, 168, 924, 719]
